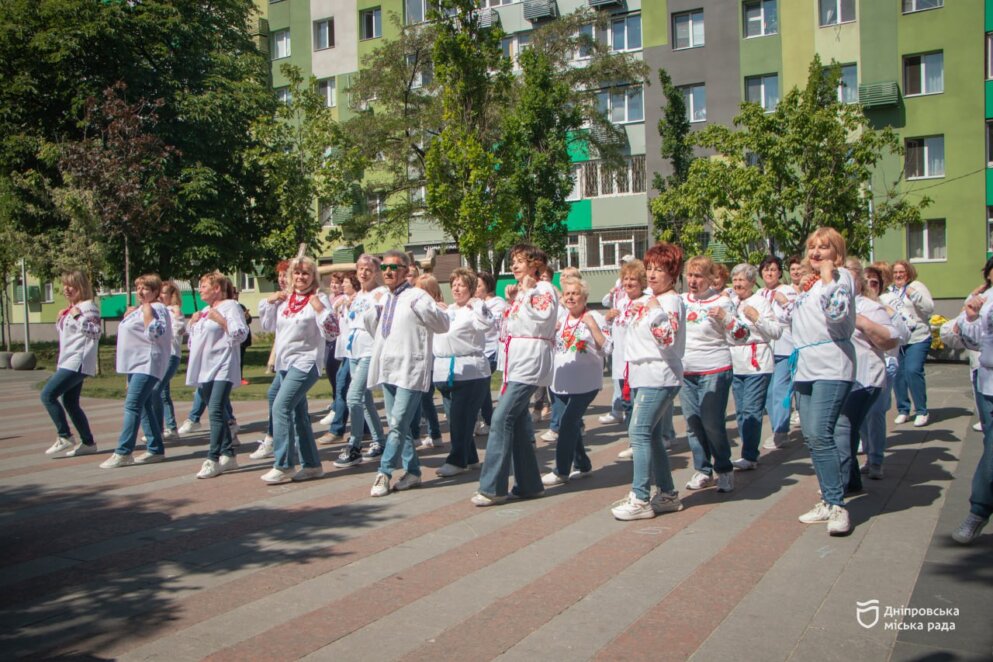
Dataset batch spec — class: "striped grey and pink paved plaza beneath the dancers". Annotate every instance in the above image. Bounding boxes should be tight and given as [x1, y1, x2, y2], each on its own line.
[0, 364, 993, 661]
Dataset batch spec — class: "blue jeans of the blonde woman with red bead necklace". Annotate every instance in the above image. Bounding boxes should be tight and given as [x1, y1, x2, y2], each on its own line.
[270, 366, 321, 471]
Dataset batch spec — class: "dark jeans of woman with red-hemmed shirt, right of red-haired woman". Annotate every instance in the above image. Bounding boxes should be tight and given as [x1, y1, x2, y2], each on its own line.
[679, 370, 734, 476]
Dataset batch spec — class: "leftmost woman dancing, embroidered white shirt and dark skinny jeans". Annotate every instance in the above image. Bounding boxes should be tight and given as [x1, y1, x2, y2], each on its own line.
[41, 270, 100, 457]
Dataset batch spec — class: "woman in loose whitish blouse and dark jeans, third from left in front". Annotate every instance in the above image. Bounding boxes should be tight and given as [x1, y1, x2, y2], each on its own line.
[186, 271, 248, 478]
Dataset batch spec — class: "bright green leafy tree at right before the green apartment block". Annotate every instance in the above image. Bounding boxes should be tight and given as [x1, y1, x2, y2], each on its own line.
[652, 57, 930, 261]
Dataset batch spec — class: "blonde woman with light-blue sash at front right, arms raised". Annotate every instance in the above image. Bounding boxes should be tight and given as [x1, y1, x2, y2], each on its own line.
[790, 228, 856, 535]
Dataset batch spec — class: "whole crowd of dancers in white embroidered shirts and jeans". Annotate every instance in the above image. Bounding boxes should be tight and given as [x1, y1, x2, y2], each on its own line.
[35, 228, 993, 543]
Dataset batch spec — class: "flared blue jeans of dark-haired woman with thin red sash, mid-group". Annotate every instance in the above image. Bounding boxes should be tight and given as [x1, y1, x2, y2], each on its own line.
[479, 382, 545, 497]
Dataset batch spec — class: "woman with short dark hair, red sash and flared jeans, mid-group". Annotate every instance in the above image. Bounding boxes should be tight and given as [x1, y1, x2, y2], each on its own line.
[472, 244, 558, 506]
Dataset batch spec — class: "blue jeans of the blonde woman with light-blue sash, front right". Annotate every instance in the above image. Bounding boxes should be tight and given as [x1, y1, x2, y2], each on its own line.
[794, 379, 852, 506]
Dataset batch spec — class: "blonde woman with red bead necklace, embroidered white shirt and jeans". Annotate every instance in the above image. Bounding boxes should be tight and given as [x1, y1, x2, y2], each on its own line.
[259, 256, 338, 485]
